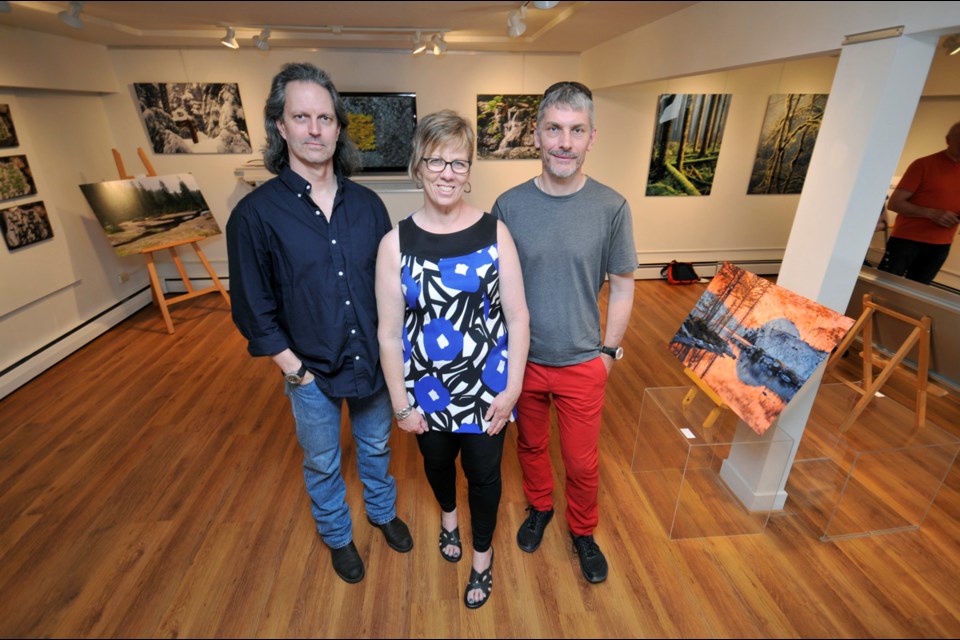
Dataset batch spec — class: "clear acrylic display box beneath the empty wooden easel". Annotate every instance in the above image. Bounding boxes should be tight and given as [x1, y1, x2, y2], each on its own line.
[786, 384, 960, 541]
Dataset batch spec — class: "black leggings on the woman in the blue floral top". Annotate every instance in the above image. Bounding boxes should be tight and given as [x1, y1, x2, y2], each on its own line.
[417, 429, 507, 553]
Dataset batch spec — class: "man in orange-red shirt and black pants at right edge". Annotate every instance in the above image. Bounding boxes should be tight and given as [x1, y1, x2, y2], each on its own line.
[880, 122, 960, 284]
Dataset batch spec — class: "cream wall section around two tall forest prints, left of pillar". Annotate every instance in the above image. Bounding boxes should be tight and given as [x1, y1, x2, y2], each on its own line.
[588, 56, 836, 277]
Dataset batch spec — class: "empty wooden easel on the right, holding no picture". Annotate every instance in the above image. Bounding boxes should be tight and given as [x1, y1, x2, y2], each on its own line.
[826, 293, 931, 432]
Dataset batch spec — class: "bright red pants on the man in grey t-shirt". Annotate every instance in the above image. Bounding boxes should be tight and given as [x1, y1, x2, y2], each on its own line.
[517, 357, 607, 536]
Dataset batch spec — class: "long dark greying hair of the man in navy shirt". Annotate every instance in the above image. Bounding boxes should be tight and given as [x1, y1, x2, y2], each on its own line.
[263, 62, 361, 176]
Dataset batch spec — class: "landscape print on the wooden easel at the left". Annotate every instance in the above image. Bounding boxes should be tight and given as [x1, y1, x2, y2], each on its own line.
[80, 173, 222, 256]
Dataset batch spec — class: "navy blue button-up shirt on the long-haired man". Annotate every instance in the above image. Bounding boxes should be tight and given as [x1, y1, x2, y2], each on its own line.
[227, 167, 391, 398]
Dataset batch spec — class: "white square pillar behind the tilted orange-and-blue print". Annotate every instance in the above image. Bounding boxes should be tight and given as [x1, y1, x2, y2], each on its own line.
[722, 30, 932, 509]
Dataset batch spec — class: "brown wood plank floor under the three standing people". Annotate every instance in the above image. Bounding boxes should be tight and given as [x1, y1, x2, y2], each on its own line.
[0, 281, 960, 638]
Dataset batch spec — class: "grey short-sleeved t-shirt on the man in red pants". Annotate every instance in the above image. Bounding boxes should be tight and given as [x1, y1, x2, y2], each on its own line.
[492, 177, 637, 366]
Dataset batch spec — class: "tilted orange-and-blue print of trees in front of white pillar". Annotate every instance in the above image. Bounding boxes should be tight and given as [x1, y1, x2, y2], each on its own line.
[669, 262, 854, 435]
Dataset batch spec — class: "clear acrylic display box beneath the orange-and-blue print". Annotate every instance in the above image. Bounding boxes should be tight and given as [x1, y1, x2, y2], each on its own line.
[631, 387, 793, 539]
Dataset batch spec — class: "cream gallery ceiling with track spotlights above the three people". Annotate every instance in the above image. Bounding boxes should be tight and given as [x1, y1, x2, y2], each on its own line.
[0, 0, 698, 53]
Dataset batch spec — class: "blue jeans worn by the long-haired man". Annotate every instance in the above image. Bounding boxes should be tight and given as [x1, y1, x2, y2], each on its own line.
[284, 383, 397, 549]
